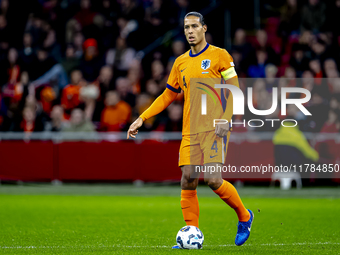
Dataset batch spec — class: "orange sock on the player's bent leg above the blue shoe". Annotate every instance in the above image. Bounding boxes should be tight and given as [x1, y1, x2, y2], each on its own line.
[214, 180, 250, 221]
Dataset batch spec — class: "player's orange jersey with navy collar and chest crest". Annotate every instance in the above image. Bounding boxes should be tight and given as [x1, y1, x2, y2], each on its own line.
[167, 44, 238, 135]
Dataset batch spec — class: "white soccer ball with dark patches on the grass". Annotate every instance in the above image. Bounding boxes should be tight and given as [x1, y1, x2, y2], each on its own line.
[176, 226, 204, 249]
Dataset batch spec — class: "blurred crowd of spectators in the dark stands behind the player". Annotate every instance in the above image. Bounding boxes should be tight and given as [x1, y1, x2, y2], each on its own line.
[0, 0, 340, 132]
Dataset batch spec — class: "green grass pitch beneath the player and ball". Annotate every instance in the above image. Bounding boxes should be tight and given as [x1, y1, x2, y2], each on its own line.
[0, 185, 340, 254]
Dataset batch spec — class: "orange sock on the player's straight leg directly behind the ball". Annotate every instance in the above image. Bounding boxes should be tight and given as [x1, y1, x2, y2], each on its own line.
[181, 190, 199, 227]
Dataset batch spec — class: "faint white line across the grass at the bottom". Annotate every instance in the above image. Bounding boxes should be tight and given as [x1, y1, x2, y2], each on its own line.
[0, 242, 340, 249]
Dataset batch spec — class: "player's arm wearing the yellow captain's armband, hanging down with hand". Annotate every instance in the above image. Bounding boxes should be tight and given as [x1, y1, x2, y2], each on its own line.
[215, 51, 240, 137]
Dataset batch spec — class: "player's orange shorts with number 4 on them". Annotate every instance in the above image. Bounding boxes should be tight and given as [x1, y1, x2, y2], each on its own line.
[178, 130, 231, 166]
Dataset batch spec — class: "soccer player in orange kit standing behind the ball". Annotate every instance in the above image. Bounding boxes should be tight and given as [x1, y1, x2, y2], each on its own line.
[127, 12, 254, 249]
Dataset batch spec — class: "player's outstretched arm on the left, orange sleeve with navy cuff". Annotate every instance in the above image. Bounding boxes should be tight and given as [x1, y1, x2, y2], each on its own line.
[127, 61, 181, 139]
